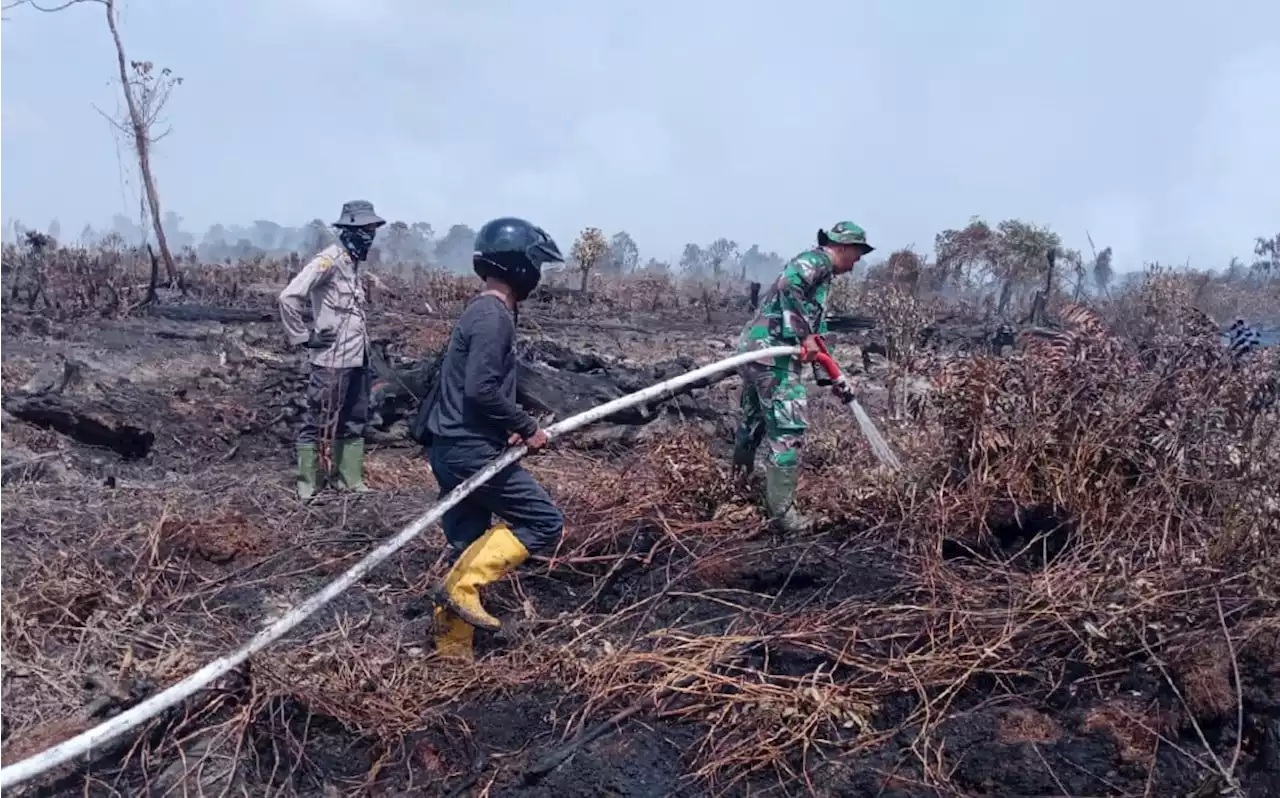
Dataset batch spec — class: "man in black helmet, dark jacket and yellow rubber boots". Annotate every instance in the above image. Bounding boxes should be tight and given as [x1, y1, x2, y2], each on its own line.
[426, 218, 564, 660]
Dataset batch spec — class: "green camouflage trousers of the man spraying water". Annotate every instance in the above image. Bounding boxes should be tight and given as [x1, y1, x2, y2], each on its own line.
[737, 356, 809, 469]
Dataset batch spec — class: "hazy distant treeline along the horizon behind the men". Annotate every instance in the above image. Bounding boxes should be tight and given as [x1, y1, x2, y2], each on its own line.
[10, 213, 1280, 297]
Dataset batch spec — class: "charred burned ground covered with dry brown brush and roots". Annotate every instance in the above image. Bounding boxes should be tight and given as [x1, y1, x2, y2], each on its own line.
[0, 266, 1280, 798]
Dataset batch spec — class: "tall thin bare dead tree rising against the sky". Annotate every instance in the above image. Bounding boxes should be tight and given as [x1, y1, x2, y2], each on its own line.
[0, 0, 182, 288]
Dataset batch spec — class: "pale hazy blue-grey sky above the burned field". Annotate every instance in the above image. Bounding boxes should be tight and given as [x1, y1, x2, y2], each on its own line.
[0, 0, 1280, 269]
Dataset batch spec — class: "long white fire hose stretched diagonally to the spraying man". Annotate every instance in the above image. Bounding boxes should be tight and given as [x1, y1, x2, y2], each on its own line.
[0, 346, 824, 790]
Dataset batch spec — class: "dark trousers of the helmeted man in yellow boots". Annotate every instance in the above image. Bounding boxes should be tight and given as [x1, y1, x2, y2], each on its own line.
[430, 438, 564, 562]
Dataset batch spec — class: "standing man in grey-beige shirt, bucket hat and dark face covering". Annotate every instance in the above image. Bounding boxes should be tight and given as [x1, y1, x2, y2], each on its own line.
[280, 200, 387, 501]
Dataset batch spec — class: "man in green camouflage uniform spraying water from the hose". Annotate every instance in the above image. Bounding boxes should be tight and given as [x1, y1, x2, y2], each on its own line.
[733, 222, 874, 533]
